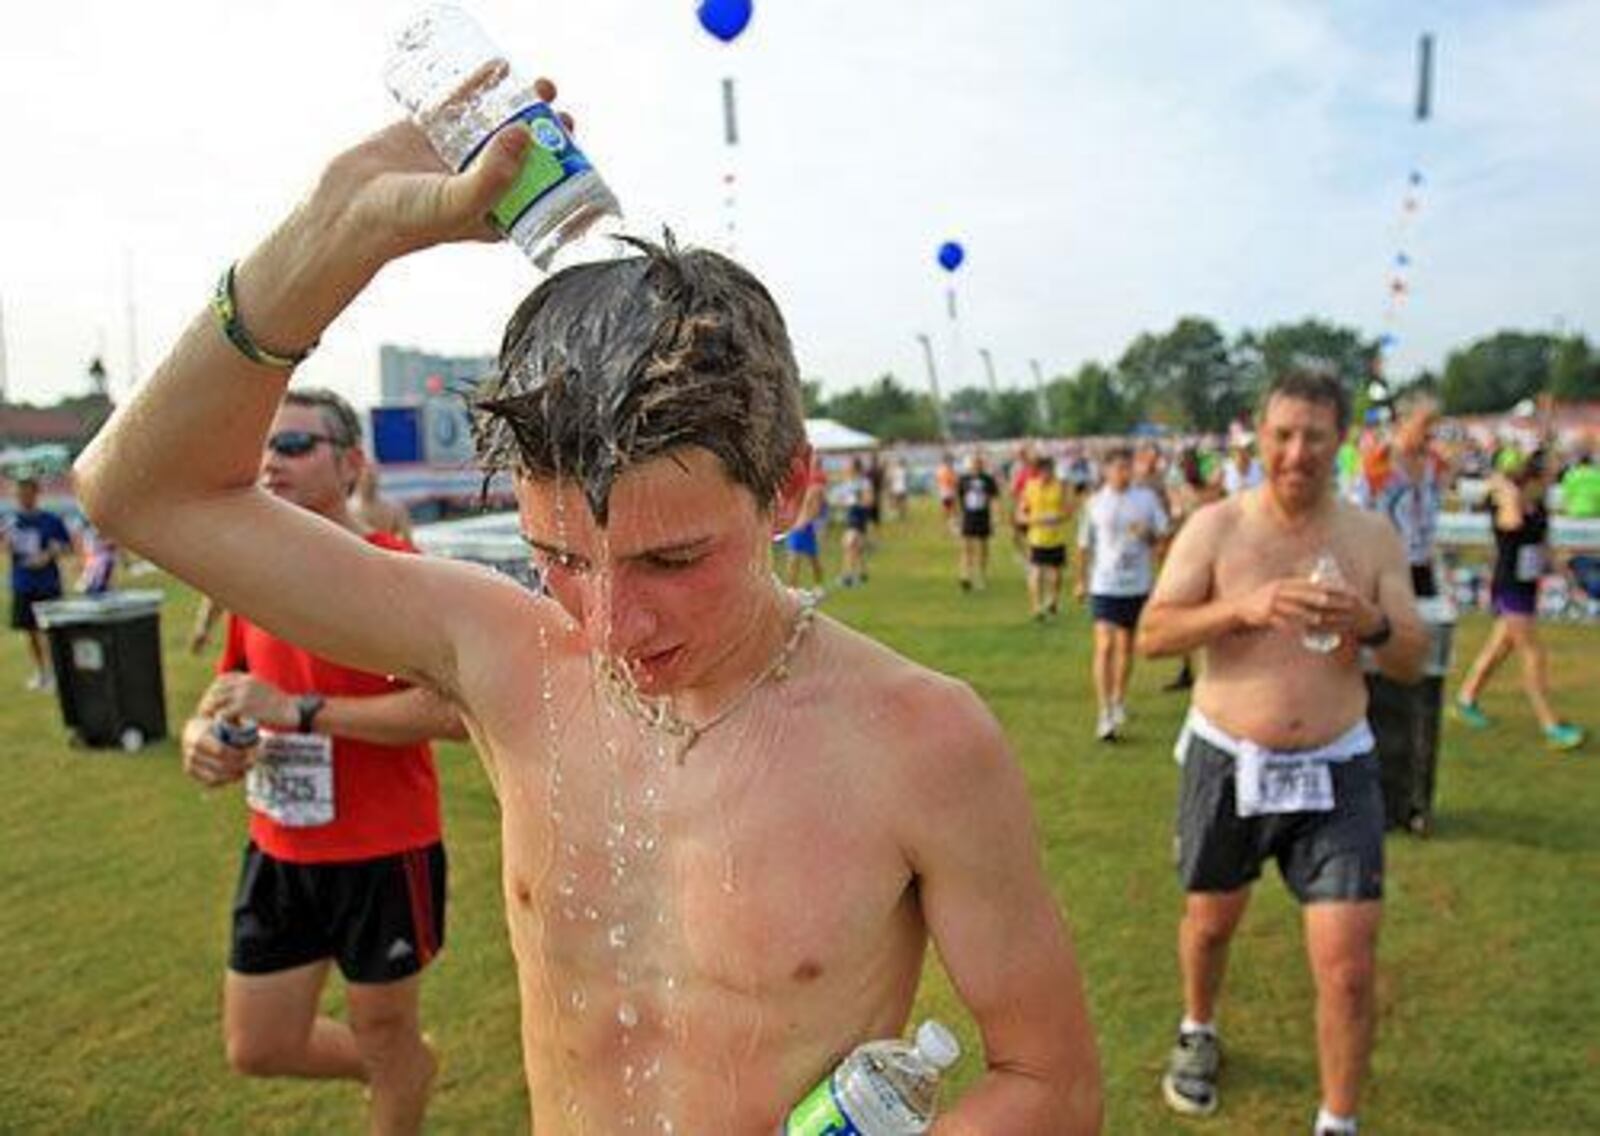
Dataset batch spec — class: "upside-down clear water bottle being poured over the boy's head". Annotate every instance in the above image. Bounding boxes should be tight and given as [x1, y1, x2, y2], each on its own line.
[384, 5, 621, 269]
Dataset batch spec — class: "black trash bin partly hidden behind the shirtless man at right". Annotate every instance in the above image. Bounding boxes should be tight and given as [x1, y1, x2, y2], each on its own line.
[1366, 597, 1456, 835]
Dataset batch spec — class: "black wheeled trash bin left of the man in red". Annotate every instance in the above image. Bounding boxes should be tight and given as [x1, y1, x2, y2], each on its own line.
[34, 590, 166, 752]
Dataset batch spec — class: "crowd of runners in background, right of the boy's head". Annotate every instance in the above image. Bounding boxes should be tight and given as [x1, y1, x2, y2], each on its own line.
[787, 404, 1600, 761]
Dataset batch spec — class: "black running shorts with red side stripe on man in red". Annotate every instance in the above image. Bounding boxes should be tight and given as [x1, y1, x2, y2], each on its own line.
[227, 842, 446, 982]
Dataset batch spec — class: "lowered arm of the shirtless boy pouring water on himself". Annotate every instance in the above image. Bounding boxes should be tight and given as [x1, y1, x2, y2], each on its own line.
[904, 680, 1101, 1136]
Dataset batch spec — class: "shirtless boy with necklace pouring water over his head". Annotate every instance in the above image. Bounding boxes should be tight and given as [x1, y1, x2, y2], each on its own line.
[78, 100, 1101, 1136]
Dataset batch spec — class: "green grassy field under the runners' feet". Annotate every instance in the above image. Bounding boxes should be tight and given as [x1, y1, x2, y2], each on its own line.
[0, 514, 1600, 1133]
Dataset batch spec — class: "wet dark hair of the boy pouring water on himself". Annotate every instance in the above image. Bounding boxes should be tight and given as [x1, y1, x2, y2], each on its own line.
[474, 234, 805, 525]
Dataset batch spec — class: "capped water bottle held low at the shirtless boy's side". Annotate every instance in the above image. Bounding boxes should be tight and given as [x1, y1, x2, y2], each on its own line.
[778, 1019, 962, 1136]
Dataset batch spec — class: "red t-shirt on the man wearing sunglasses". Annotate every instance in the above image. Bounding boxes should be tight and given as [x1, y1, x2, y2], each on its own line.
[218, 533, 443, 864]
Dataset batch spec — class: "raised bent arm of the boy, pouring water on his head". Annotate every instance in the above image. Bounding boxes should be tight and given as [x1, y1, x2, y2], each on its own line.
[75, 113, 537, 694]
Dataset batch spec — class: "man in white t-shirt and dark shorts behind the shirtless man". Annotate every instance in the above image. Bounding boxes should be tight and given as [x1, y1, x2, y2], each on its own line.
[1077, 446, 1168, 741]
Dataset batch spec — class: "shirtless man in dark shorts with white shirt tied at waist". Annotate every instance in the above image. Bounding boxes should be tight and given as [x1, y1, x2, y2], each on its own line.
[1138, 373, 1427, 1134]
